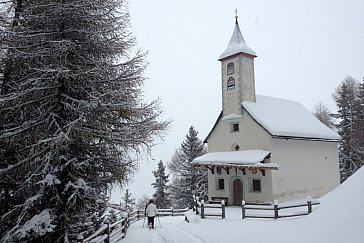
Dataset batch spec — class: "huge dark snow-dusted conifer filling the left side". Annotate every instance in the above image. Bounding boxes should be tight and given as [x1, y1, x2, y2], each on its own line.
[0, 0, 168, 242]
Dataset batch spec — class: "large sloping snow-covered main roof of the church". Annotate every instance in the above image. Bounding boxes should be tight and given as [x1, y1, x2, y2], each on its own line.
[242, 95, 341, 140]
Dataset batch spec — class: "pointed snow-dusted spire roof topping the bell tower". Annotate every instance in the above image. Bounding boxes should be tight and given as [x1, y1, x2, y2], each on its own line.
[219, 19, 257, 61]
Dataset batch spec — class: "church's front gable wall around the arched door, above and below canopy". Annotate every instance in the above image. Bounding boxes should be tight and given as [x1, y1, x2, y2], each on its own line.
[208, 112, 277, 205]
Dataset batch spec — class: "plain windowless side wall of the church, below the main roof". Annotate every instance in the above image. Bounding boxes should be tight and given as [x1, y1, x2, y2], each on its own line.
[271, 139, 340, 201]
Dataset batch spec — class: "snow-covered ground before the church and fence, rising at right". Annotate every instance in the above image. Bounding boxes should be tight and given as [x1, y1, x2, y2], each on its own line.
[121, 168, 364, 243]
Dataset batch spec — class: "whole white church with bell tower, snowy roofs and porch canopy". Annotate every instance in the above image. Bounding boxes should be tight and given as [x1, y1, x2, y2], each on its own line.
[193, 17, 340, 205]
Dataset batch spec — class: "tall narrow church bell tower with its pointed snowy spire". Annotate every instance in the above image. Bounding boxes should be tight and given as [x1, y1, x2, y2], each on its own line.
[218, 15, 257, 116]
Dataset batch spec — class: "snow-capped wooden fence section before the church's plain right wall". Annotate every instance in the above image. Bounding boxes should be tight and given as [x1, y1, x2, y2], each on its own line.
[241, 197, 320, 219]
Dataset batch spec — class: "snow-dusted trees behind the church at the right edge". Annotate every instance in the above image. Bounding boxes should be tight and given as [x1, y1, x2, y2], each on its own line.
[313, 76, 364, 182]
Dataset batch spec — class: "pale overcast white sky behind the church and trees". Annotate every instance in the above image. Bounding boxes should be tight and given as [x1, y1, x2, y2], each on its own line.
[111, 0, 364, 201]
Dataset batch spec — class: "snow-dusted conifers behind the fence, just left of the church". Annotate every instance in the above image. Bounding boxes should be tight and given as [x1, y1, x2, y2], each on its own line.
[122, 126, 207, 211]
